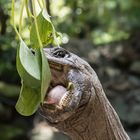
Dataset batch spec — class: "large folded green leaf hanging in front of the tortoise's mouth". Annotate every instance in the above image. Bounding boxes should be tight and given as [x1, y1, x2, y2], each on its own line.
[16, 40, 51, 116]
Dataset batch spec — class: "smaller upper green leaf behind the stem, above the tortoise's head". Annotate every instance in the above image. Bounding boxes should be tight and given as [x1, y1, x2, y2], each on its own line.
[30, 10, 54, 48]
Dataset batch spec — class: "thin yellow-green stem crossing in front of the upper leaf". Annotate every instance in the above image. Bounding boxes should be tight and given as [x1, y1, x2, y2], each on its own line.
[32, 0, 43, 48]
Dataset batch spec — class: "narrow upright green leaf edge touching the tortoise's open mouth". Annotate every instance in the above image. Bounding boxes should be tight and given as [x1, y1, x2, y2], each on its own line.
[40, 48, 51, 102]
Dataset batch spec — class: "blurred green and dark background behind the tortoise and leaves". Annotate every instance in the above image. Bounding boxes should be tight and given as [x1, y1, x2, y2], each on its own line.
[0, 0, 140, 140]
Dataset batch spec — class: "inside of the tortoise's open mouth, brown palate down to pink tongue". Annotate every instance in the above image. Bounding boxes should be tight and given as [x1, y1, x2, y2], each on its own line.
[43, 61, 72, 107]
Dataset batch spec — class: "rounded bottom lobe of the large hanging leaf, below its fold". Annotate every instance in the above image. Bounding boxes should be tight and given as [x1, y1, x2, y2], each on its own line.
[16, 83, 40, 116]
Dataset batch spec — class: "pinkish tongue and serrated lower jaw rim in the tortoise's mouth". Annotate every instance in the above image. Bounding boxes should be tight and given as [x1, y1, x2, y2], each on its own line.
[43, 82, 73, 112]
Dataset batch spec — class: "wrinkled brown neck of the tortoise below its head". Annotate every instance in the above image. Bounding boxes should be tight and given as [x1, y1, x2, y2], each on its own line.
[56, 89, 130, 140]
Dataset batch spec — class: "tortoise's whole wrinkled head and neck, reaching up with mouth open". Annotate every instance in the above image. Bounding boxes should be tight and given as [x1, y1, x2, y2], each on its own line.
[40, 47, 129, 140]
